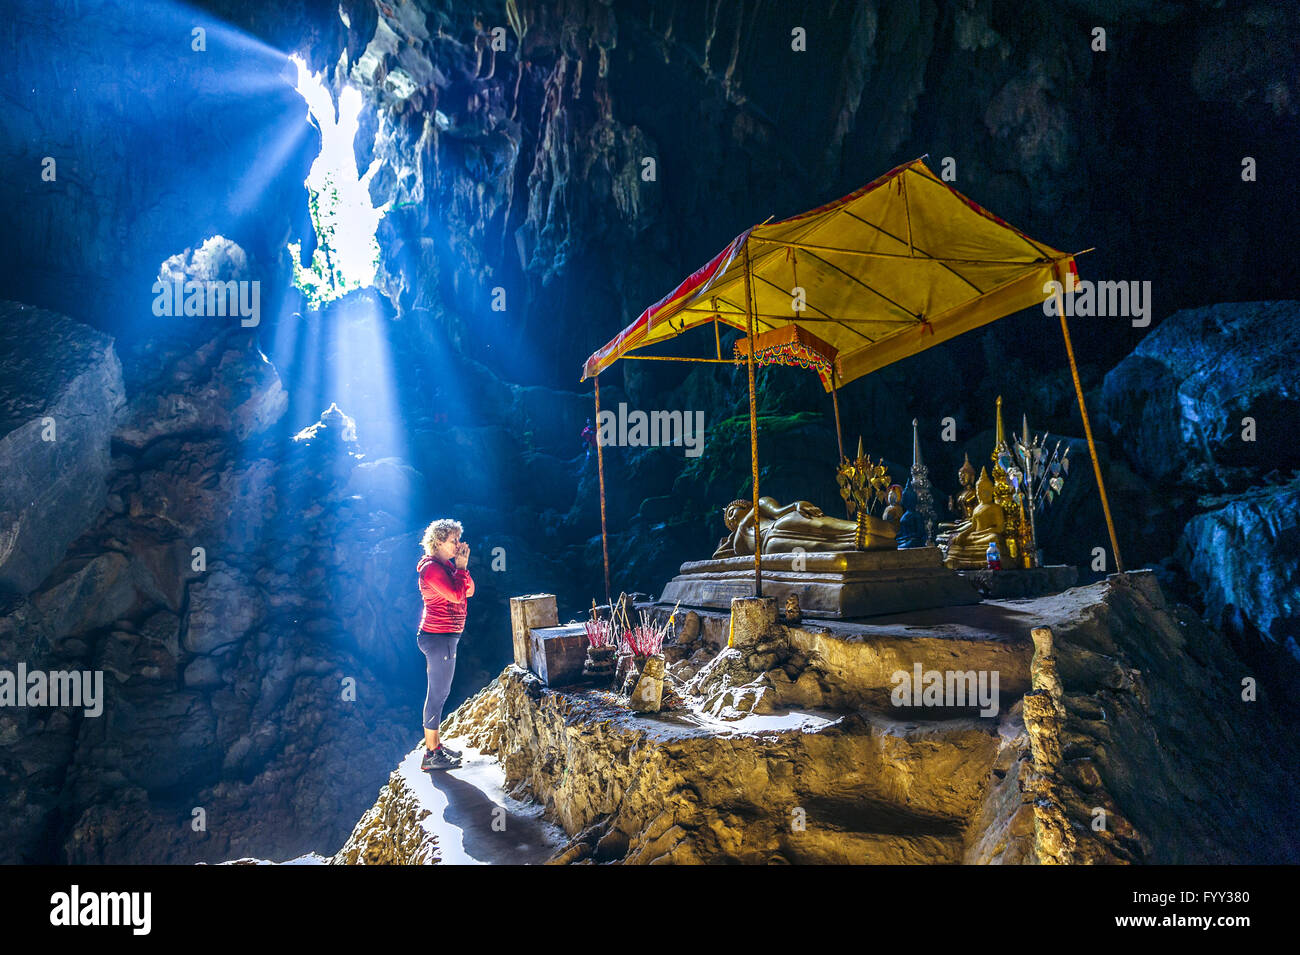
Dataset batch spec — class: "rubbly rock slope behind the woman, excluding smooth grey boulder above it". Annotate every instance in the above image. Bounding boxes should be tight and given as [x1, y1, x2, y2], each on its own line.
[0, 384, 421, 863]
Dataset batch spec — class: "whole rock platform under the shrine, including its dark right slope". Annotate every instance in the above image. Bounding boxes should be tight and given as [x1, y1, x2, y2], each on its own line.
[337, 573, 1300, 864]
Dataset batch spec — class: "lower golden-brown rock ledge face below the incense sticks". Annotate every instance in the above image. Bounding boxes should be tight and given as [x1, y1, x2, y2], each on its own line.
[462, 669, 996, 863]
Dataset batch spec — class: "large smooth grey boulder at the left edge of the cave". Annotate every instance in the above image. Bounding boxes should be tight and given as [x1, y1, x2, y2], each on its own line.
[0, 301, 124, 594]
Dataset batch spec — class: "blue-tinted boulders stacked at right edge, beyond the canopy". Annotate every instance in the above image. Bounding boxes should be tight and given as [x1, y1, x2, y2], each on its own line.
[1101, 301, 1300, 686]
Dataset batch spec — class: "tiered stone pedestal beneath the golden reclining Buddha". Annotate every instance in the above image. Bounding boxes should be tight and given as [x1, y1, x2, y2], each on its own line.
[659, 547, 980, 618]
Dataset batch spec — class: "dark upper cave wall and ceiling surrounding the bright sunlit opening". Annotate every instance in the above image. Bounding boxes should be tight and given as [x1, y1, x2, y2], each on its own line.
[0, 0, 1297, 387]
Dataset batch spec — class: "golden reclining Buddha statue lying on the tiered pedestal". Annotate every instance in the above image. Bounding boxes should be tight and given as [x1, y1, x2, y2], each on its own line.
[714, 498, 896, 560]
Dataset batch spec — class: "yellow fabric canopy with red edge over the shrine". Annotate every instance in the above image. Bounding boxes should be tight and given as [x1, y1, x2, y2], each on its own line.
[582, 160, 1076, 391]
